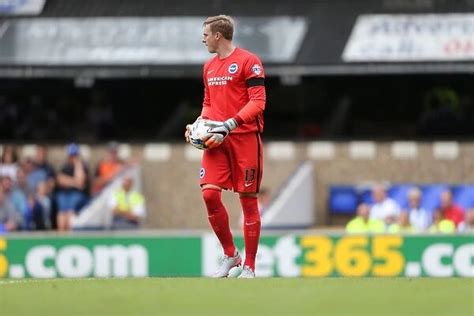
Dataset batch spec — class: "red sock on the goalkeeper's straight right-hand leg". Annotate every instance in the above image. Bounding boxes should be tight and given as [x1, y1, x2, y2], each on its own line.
[240, 196, 260, 271]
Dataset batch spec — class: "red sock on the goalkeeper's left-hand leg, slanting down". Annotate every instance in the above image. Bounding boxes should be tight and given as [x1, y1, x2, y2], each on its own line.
[202, 189, 235, 257]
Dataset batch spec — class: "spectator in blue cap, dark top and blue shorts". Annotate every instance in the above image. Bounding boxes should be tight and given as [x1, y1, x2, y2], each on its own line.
[56, 144, 88, 231]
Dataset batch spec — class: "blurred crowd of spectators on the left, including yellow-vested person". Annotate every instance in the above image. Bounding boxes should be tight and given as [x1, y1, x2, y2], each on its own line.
[0, 142, 144, 233]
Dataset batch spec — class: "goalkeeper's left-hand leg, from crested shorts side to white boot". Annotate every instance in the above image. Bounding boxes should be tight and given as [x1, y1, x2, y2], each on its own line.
[200, 147, 242, 277]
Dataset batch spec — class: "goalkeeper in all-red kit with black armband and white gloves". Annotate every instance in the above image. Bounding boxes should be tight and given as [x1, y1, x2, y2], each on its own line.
[185, 15, 266, 278]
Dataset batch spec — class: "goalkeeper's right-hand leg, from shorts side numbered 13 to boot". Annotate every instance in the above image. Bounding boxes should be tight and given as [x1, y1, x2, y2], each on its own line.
[229, 133, 263, 275]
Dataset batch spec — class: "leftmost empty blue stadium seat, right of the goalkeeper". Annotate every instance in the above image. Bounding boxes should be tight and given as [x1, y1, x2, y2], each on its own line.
[329, 185, 358, 215]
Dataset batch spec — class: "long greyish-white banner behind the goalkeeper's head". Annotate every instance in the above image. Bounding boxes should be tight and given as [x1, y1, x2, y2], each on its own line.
[0, 17, 308, 65]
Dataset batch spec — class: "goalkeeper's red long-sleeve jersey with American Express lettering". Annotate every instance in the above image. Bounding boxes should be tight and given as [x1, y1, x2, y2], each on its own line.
[201, 48, 266, 133]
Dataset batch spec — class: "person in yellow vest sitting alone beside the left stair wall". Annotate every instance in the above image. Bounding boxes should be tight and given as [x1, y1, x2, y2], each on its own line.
[109, 176, 145, 229]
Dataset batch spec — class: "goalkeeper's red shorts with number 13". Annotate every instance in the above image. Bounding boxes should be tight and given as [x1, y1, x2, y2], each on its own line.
[199, 133, 263, 193]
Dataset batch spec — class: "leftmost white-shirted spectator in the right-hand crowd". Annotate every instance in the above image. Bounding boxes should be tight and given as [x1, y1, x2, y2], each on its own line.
[370, 184, 400, 226]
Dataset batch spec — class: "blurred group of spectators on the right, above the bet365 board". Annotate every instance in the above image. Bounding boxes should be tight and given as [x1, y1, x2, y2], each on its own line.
[346, 184, 474, 234]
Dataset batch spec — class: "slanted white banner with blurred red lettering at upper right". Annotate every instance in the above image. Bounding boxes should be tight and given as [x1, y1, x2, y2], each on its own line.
[342, 13, 474, 62]
